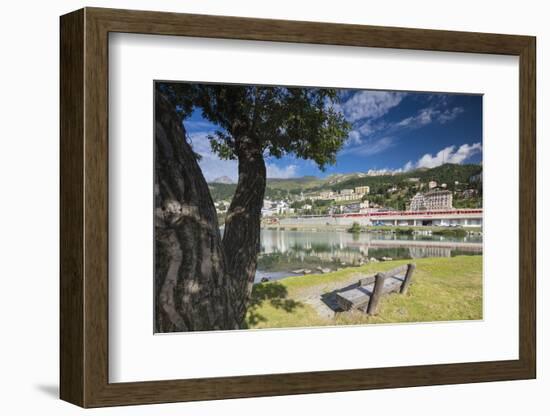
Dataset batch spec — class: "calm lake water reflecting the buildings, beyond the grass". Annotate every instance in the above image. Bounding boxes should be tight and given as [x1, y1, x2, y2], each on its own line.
[256, 229, 483, 281]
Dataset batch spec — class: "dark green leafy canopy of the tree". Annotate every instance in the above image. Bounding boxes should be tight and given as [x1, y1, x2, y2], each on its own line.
[157, 83, 351, 169]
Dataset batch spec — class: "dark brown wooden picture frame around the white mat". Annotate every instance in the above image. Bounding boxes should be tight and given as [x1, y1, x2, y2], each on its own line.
[60, 8, 536, 407]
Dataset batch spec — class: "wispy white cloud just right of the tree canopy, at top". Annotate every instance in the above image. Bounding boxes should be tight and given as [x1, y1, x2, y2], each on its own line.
[340, 91, 405, 123]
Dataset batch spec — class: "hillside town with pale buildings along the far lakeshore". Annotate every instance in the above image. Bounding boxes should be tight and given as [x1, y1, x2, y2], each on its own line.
[215, 164, 483, 229]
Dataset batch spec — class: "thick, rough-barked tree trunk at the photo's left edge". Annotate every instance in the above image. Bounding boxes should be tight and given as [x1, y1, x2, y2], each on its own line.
[155, 91, 243, 332]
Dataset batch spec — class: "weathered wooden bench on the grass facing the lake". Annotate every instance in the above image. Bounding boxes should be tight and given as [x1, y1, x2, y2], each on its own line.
[336, 264, 416, 315]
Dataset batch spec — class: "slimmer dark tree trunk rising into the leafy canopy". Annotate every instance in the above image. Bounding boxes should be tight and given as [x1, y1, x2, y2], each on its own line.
[223, 136, 266, 325]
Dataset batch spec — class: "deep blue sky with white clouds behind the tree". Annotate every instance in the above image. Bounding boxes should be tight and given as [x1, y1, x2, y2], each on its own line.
[184, 90, 482, 181]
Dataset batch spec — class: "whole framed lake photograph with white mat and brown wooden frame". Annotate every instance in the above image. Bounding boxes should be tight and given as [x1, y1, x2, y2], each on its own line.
[60, 8, 536, 407]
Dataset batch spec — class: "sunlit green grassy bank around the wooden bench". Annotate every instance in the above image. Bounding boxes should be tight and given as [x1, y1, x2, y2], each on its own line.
[247, 256, 483, 328]
